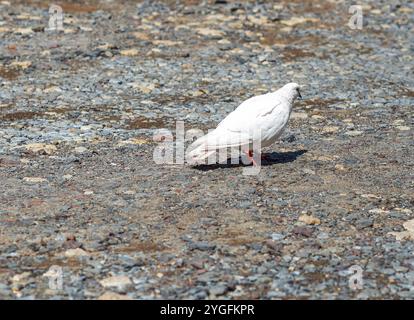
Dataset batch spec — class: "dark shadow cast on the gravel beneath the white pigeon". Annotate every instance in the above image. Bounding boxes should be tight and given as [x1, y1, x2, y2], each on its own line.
[193, 150, 308, 171]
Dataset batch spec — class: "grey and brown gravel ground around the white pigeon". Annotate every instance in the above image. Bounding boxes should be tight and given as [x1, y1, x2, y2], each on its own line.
[0, 0, 414, 299]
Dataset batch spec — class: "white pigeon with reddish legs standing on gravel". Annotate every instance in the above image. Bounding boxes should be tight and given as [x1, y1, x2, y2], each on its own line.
[186, 83, 302, 165]
